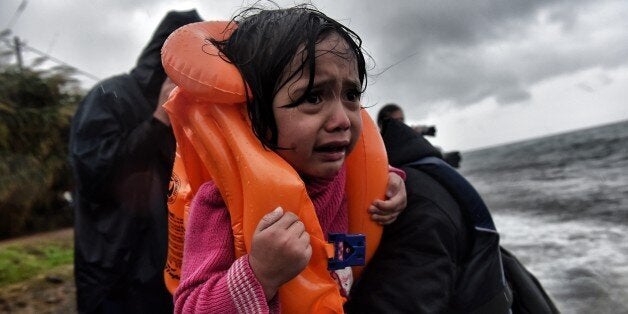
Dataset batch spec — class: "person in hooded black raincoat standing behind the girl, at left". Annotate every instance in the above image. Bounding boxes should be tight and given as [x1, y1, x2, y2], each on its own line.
[70, 10, 201, 313]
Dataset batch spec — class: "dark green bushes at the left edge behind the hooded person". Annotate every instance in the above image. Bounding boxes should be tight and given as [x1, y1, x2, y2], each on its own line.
[0, 40, 83, 239]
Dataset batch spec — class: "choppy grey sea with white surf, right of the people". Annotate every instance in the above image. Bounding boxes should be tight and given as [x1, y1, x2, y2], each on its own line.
[459, 121, 628, 313]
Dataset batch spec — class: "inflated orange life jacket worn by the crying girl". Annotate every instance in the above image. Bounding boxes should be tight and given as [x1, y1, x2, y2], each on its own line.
[162, 22, 388, 313]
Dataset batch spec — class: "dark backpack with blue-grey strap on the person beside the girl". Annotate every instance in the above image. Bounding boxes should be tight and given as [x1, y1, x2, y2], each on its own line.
[406, 157, 559, 314]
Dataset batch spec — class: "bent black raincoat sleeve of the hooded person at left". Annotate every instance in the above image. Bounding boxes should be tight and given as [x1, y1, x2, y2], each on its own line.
[70, 80, 174, 199]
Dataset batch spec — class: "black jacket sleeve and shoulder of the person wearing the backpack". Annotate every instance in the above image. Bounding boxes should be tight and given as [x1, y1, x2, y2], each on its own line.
[346, 168, 472, 313]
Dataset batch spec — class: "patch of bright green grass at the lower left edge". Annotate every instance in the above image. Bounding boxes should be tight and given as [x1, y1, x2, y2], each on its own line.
[0, 242, 74, 287]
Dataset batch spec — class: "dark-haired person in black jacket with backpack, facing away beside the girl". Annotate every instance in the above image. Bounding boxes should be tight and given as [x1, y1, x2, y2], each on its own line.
[345, 118, 558, 314]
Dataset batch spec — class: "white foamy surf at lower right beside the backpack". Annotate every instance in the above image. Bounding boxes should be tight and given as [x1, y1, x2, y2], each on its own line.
[494, 213, 628, 313]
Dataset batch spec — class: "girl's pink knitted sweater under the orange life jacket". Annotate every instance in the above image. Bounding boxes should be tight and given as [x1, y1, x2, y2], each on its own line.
[174, 167, 352, 313]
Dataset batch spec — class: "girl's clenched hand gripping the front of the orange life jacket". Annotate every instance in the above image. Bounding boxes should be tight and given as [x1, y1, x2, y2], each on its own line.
[249, 207, 312, 300]
